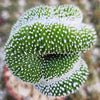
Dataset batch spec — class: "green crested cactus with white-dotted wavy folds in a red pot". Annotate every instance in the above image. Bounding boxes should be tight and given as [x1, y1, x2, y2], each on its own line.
[5, 5, 96, 96]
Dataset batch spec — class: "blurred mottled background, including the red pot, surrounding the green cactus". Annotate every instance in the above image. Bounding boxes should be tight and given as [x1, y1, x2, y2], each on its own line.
[0, 0, 100, 100]
